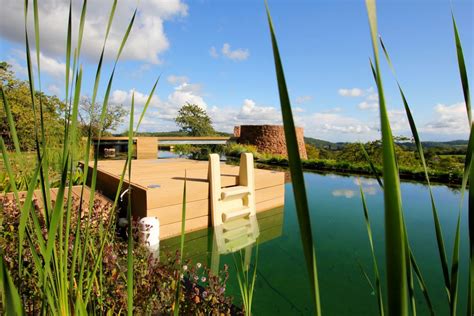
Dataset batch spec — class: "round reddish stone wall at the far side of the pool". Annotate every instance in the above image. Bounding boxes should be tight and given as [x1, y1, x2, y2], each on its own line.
[234, 125, 307, 159]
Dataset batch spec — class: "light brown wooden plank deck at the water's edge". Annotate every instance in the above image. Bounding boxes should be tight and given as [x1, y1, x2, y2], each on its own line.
[84, 159, 285, 239]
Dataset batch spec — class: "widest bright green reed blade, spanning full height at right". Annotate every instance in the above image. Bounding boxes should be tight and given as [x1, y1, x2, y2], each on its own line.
[366, 0, 408, 315]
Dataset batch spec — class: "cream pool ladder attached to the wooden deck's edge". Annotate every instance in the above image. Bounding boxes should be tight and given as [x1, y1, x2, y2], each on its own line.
[209, 153, 256, 226]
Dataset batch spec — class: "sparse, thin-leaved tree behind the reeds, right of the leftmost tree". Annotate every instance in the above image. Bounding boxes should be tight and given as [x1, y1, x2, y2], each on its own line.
[79, 98, 128, 137]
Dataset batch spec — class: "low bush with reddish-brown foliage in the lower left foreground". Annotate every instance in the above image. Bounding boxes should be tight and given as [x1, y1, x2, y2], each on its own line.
[0, 196, 232, 315]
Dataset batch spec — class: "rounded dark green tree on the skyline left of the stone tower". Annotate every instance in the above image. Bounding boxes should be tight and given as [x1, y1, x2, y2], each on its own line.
[175, 103, 216, 136]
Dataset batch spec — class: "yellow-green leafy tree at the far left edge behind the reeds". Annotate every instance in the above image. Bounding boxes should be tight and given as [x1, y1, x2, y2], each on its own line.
[0, 62, 66, 151]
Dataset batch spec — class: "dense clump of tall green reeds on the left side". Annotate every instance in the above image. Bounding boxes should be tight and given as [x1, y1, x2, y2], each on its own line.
[0, 0, 158, 315]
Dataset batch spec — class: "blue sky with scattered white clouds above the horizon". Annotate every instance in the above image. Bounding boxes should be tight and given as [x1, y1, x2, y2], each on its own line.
[0, 0, 474, 141]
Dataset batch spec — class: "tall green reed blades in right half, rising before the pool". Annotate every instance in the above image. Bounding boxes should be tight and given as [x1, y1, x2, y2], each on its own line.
[267, 0, 474, 315]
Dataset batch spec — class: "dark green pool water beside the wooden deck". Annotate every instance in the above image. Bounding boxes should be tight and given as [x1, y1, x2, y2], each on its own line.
[160, 173, 468, 315]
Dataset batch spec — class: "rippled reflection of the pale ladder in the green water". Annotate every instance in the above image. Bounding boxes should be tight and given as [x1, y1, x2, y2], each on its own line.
[211, 216, 260, 273]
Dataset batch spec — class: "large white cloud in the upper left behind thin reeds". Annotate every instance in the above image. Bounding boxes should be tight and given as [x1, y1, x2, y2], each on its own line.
[0, 0, 188, 64]
